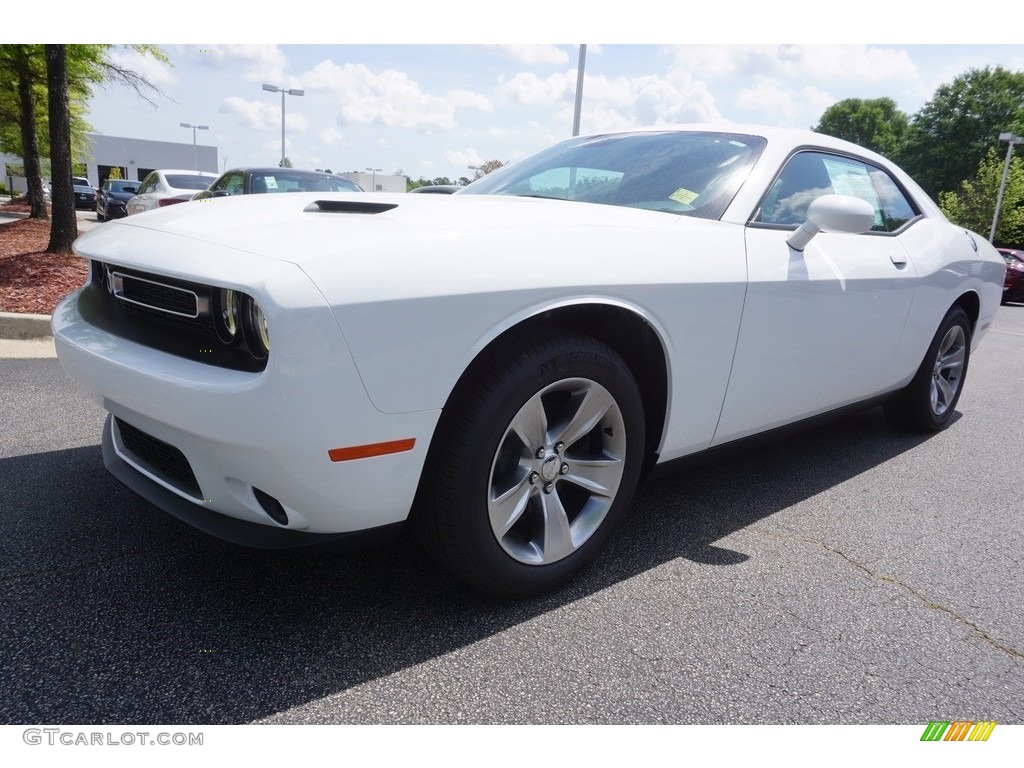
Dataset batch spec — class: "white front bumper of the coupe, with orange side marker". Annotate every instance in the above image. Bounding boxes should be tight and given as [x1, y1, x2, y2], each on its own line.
[53, 254, 439, 546]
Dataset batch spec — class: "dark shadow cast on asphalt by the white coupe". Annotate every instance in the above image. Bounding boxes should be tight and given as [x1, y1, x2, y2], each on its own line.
[0, 409, 926, 724]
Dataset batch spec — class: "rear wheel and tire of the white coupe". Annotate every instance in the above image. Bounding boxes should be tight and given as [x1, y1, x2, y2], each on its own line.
[886, 306, 971, 432]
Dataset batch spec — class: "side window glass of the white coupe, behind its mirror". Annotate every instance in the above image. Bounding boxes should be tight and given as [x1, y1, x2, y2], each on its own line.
[754, 152, 918, 232]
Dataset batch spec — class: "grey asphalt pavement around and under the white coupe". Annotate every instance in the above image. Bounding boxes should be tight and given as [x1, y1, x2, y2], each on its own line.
[0, 306, 1024, 725]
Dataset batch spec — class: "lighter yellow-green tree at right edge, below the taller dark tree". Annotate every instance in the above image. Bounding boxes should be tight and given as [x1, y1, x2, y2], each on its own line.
[939, 148, 1024, 248]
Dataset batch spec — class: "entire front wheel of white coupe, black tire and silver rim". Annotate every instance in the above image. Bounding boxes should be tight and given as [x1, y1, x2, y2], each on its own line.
[414, 331, 644, 597]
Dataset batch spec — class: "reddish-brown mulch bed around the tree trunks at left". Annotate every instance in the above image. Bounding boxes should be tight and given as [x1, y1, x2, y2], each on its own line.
[0, 204, 88, 314]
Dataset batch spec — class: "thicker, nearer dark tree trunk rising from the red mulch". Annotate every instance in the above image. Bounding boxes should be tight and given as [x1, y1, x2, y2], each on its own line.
[46, 45, 78, 253]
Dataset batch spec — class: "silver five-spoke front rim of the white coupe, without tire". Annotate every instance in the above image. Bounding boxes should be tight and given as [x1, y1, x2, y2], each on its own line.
[487, 378, 627, 565]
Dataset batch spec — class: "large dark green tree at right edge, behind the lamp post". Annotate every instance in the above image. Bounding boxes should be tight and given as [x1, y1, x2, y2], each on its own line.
[897, 67, 1024, 198]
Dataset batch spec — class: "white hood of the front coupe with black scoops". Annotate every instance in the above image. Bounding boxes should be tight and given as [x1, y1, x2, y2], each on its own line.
[75, 193, 704, 266]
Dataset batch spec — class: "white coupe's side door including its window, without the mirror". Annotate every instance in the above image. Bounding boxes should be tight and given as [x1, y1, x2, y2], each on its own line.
[713, 151, 920, 444]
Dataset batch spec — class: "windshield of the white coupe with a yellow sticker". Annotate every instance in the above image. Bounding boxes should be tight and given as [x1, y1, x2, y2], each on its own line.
[458, 131, 765, 218]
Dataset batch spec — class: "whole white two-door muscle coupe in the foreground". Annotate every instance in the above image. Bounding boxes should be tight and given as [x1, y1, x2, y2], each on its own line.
[53, 126, 1005, 596]
